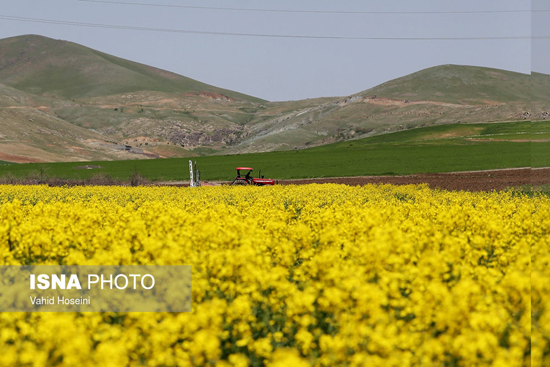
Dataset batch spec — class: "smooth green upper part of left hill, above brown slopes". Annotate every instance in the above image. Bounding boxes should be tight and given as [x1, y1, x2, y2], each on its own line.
[0, 35, 261, 102]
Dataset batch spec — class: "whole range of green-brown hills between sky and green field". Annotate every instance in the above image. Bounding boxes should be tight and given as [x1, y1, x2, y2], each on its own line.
[0, 35, 550, 162]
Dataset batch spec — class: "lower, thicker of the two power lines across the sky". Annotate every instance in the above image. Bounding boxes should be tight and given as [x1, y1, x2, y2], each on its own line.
[0, 15, 536, 41]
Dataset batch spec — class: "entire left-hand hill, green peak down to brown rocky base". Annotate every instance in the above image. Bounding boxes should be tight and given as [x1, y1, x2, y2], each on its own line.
[0, 35, 272, 162]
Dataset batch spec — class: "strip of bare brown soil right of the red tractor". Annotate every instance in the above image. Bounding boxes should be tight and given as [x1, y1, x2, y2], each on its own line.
[279, 168, 550, 191]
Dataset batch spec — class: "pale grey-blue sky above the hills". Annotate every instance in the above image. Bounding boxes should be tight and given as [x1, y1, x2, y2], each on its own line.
[0, 0, 550, 101]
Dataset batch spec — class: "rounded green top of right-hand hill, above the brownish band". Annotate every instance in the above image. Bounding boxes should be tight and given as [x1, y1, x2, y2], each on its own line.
[360, 65, 550, 104]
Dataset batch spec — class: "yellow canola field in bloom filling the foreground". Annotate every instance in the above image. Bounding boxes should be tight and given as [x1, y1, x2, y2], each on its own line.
[0, 185, 550, 366]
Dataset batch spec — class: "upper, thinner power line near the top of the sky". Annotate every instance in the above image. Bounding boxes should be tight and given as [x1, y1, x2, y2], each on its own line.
[78, 0, 540, 14]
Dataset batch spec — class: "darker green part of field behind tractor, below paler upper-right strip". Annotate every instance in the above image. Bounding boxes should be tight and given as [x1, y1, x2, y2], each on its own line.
[0, 142, 536, 180]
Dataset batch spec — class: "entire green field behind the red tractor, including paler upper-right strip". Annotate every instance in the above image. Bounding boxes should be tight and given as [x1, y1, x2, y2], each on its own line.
[0, 121, 550, 180]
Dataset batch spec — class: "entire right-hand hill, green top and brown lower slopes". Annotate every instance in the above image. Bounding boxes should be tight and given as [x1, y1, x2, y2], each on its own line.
[232, 65, 550, 152]
